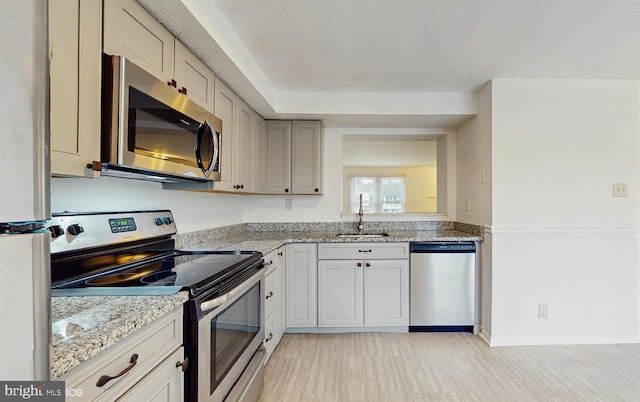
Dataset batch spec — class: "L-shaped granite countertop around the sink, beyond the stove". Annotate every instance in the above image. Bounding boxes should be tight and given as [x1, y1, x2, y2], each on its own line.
[180, 230, 482, 254]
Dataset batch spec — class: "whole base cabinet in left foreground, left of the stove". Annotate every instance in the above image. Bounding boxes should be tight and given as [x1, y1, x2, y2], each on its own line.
[58, 306, 184, 402]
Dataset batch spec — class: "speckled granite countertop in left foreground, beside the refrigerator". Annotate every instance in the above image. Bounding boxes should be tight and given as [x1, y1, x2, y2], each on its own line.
[50, 292, 189, 380]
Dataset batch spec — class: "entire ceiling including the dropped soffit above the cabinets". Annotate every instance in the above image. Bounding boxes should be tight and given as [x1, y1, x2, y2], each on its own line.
[137, 0, 640, 129]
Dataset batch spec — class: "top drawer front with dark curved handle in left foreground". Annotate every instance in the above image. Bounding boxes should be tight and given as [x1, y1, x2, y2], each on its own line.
[60, 306, 182, 401]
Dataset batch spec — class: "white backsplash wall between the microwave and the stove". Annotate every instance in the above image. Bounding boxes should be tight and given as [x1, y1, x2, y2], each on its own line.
[51, 177, 244, 233]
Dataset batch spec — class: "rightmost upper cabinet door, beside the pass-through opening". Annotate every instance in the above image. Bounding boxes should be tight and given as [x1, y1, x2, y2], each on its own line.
[292, 121, 323, 194]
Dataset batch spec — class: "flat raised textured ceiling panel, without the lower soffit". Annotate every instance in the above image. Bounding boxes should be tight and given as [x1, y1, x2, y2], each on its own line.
[216, 0, 640, 92]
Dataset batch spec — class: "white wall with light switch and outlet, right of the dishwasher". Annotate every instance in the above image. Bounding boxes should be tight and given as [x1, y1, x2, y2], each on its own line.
[488, 80, 640, 345]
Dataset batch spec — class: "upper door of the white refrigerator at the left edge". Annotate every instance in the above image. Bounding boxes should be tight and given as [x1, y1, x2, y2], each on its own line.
[0, 0, 50, 223]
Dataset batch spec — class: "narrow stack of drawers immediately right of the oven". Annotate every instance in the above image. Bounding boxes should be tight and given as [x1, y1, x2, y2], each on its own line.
[264, 247, 286, 364]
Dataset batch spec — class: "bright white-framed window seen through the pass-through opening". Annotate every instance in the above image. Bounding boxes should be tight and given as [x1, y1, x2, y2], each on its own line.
[351, 176, 405, 214]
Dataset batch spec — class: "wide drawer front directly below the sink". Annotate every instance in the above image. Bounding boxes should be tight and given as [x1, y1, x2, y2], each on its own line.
[318, 243, 409, 260]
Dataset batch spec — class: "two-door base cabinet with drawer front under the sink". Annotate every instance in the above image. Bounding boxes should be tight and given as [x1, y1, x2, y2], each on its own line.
[318, 243, 409, 327]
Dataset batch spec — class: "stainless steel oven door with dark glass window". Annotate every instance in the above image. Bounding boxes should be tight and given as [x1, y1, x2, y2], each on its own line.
[196, 270, 265, 402]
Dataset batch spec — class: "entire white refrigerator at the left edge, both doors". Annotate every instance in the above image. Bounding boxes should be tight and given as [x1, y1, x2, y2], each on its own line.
[0, 0, 51, 381]
